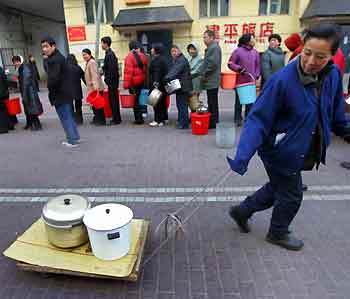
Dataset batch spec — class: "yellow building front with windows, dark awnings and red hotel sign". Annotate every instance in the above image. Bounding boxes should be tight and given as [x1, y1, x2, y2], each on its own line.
[64, 0, 309, 68]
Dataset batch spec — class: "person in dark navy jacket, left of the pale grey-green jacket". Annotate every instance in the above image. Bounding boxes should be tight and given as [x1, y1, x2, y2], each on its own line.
[164, 45, 193, 129]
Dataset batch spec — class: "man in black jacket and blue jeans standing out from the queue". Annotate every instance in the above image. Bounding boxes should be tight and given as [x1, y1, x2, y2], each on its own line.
[41, 37, 80, 147]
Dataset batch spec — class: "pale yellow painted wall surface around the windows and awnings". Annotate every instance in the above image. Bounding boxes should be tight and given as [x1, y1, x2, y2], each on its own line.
[64, 0, 309, 66]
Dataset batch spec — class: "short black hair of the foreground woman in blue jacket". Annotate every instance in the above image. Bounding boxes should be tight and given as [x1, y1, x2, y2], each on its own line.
[303, 24, 341, 55]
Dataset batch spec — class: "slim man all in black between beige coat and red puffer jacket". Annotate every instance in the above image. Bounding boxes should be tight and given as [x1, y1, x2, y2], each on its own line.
[101, 36, 122, 125]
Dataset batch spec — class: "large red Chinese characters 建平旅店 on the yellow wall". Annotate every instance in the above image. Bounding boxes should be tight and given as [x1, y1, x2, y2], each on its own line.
[206, 22, 274, 44]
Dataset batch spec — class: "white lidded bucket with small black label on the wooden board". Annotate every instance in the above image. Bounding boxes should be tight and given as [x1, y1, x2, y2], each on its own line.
[83, 204, 134, 261]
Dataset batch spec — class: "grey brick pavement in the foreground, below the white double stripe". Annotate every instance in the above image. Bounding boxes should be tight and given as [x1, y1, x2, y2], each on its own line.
[0, 201, 350, 299]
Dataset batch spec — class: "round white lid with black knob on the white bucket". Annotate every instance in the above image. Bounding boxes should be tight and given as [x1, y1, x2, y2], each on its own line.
[83, 203, 134, 231]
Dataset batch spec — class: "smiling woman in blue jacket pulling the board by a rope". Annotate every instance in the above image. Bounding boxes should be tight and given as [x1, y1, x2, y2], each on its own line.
[228, 24, 350, 250]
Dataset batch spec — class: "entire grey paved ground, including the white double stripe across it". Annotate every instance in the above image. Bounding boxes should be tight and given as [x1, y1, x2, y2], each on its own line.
[0, 91, 350, 299]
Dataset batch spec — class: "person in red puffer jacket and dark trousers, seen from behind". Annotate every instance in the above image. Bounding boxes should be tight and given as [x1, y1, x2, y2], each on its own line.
[123, 41, 147, 125]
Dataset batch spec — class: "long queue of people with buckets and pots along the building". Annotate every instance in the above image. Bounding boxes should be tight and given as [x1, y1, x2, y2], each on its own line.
[0, 30, 348, 154]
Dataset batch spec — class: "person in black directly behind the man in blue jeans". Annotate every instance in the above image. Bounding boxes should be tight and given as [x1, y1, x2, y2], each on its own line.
[67, 54, 85, 124]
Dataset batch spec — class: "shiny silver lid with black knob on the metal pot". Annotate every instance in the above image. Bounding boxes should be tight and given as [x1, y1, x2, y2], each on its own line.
[42, 194, 91, 226]
